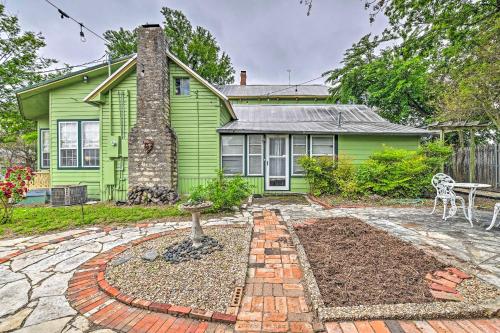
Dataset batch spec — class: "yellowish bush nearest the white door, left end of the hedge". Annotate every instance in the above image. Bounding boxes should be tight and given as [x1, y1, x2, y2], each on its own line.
[299, 156, 358, 197]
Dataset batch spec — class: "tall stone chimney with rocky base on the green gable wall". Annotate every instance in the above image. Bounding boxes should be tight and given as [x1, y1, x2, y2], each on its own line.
[128, 24, 177, 203]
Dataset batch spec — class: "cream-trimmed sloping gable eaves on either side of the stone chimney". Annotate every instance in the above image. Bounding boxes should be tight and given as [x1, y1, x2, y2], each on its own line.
[83, 51, 237, 119]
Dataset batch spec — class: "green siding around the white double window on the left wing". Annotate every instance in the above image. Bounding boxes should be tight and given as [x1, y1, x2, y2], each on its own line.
[49, 76, 105, 199]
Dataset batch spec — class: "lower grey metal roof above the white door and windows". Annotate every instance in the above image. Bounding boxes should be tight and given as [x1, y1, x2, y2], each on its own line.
[217, 104, 432, 135]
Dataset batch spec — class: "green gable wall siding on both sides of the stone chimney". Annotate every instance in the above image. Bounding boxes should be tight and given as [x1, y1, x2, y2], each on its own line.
[101, 62, 230, 200]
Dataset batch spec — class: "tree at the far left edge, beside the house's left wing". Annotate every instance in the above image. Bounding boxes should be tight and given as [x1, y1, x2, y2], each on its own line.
[0, 4, 55, 164]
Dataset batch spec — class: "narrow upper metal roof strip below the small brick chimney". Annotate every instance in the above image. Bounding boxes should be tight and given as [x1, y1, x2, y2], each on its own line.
[217, 84, 330, 98]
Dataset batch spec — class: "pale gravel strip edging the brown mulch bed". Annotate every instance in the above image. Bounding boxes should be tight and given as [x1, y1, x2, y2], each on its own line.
[286, 214, 500, 321]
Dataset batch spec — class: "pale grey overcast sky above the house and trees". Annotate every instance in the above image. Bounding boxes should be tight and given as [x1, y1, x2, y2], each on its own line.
[0, 0, 386, 84]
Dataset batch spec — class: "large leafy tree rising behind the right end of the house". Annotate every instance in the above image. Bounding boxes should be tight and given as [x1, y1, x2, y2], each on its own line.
[327, 0, 500, 125]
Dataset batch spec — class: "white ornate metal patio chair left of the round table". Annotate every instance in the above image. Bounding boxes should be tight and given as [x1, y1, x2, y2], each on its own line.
[431, 172, 467, 221]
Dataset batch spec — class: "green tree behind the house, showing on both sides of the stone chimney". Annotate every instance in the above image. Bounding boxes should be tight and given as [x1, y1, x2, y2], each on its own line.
[104, 7, 234, 85]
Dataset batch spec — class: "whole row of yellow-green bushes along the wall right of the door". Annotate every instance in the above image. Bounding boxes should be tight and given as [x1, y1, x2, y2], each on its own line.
[299, 142, 452, 198]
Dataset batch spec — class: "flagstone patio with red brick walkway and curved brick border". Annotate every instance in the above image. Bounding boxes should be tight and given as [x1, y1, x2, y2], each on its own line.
[0, 200, 500, 333]
